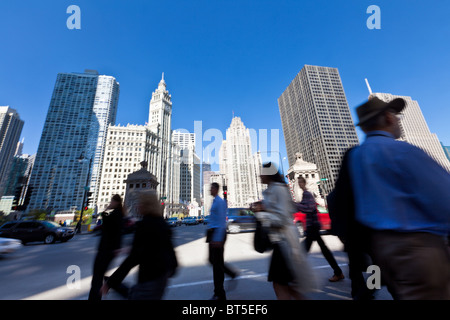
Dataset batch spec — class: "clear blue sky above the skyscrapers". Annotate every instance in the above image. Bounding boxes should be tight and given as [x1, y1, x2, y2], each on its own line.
[0, 0, 450, 170]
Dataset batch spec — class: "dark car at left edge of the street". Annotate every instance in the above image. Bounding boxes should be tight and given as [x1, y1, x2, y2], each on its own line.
[0, 220, 74, 244]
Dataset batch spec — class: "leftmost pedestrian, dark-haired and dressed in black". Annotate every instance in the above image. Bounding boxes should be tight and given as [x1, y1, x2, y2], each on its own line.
[89, 194, 127, 300]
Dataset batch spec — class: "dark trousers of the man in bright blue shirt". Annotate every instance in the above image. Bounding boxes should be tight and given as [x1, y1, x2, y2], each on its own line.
[209, 244, 236, 299]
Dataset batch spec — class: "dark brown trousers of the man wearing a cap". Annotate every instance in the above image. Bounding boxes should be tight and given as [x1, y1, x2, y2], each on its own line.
[372, 231, 450, 300]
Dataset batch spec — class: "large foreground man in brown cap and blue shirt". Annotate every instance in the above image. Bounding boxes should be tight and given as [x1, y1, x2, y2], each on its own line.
[336, 97, 450, 299]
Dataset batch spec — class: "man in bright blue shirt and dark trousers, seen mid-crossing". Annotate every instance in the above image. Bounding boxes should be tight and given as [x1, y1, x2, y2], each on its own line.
[206, 182, 238, 301]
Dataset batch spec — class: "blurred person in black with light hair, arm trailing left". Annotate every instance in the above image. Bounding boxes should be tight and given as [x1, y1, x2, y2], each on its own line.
[101, 191, 178, 300]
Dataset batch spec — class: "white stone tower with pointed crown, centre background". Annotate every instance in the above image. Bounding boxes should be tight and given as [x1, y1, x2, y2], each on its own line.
[219, 117, 263, 208]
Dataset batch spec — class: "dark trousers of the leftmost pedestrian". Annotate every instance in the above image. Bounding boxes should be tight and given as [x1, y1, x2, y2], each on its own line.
[89, 250, 128, 300]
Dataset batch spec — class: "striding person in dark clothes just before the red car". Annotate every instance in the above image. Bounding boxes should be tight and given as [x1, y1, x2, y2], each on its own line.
[295, 176, 345, 282]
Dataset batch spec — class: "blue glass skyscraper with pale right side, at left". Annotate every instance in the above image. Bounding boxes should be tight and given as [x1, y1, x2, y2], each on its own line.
[28, 70, 120, 211]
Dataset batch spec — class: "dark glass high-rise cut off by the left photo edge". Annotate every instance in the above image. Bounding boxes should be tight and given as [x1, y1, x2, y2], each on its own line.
[0, 106, 24, 197]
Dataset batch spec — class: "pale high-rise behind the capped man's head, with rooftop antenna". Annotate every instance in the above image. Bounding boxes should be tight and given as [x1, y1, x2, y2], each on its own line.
[369, 93, 450, 172]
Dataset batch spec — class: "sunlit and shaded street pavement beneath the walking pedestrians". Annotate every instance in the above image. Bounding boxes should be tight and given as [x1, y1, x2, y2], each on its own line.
[0, 225, 391, 300]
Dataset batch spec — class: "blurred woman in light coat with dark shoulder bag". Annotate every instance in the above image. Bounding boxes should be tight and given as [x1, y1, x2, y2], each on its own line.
[255, 162, 315, 300]
